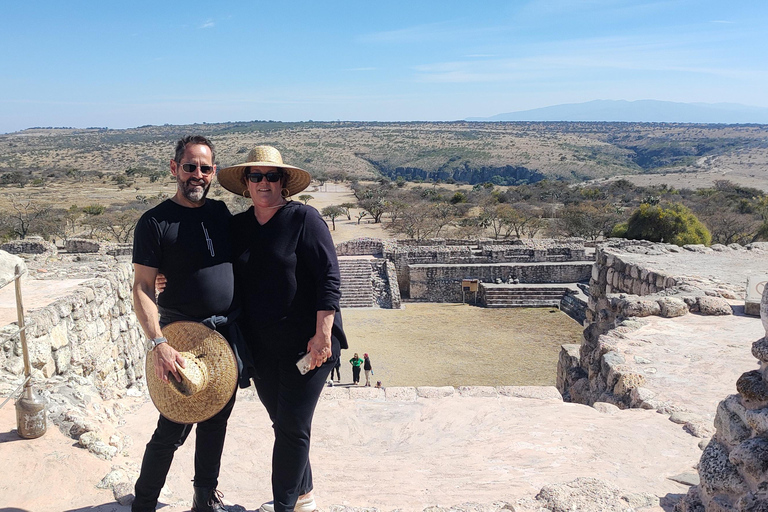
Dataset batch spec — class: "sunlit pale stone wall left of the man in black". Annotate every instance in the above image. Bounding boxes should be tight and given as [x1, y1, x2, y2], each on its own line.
[0, 261, 146, 444]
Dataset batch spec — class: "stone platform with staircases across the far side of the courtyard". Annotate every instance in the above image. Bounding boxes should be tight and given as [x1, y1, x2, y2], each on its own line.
[336, 238, 592, 322]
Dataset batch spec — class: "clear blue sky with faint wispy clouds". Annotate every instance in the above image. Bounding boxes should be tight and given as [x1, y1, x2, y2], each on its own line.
[0, 0, 768, 133]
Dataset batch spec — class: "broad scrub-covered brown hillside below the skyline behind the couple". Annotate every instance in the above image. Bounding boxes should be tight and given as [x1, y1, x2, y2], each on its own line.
[0, 121, 768, 187]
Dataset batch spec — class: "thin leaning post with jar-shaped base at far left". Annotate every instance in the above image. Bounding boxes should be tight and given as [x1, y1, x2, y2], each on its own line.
[14, 265, 46, 439]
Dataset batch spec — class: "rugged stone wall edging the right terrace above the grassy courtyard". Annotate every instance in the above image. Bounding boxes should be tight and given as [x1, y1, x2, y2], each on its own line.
[557, 240, 736, 408]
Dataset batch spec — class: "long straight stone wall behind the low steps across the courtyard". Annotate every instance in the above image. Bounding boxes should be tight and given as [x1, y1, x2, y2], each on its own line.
[408, 262, 592, 302]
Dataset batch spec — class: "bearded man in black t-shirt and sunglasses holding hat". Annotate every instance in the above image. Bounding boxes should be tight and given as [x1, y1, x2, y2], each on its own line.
[131, 136, 235, 512]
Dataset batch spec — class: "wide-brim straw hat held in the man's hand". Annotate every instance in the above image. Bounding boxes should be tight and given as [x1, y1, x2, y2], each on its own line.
[146, 322, 237, 423]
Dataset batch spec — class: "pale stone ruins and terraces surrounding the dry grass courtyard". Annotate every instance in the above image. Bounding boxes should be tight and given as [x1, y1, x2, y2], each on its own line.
[0, 238, 768, 512]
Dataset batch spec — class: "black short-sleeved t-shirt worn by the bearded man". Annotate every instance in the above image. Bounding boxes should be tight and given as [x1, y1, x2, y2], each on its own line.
[133, 199, 234, 321]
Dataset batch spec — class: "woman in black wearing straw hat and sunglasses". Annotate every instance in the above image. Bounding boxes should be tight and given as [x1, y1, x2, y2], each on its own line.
[218, 146, 347, 512]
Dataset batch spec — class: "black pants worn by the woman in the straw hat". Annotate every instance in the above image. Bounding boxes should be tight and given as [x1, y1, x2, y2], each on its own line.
[255, 354, 338, 512]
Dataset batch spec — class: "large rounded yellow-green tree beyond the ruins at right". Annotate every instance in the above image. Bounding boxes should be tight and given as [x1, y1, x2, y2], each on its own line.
[624, 203, 712, 246]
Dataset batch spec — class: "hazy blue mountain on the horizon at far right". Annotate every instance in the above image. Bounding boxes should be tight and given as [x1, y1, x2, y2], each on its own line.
[467, 100, 768, 124]
